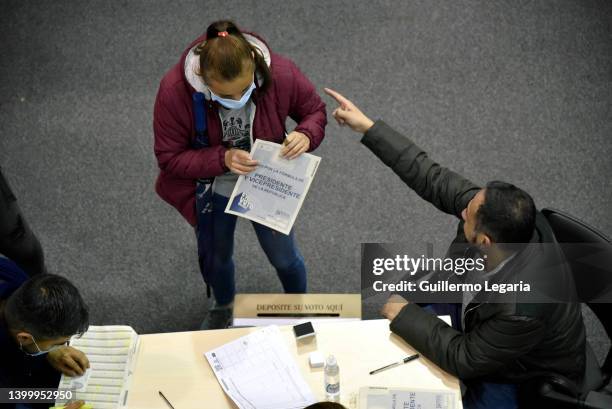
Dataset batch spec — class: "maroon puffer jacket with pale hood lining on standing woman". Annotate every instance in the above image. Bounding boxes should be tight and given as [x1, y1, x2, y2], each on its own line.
[153, 33, 327, 225]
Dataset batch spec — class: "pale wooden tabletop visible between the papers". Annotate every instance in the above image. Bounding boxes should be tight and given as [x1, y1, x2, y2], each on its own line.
[127, 320, 462, 409]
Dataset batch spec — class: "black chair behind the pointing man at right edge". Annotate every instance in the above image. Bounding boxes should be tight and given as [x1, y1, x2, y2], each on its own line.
[529, 209, 612, 409]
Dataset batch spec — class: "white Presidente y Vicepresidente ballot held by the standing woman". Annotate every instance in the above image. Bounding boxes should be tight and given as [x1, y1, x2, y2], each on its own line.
[225, 139, 321, 234]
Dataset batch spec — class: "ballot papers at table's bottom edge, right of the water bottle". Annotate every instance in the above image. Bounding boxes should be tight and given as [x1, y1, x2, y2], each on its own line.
[359, 387, 457, 409]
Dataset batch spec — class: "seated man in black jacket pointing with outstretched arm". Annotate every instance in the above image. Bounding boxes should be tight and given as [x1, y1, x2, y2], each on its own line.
[326, 89, 586, 409]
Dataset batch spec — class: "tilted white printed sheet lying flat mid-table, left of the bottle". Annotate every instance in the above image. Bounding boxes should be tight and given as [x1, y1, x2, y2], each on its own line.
[204, 325, 315, 409]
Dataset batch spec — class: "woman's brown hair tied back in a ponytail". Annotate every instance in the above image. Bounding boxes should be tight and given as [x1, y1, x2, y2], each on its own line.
[195, 20, 272, 92]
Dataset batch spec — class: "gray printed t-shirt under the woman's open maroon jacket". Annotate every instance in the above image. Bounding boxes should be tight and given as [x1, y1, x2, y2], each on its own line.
[213, 100, 255, 197]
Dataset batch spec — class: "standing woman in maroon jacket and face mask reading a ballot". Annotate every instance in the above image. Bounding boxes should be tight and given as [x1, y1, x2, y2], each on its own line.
[153, 21, 327, 329]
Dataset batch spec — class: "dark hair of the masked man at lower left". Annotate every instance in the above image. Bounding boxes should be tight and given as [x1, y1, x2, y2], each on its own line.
[4, 274, 89, 340]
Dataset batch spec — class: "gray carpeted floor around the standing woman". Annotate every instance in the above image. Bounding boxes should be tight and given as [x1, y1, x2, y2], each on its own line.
[0, 0, 612, 356]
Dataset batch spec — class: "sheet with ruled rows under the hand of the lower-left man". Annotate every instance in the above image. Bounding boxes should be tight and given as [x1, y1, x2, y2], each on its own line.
[55, 325, 138, 409]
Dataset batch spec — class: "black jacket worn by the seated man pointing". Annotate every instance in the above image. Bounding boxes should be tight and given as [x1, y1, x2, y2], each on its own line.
[362, 121, 586, 385]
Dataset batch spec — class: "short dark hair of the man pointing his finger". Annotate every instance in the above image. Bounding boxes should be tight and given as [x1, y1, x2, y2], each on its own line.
[476, 181, 536, 243]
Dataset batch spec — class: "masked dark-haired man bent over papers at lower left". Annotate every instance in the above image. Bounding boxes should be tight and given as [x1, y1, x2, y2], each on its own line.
[0, 256, 89, 409]
